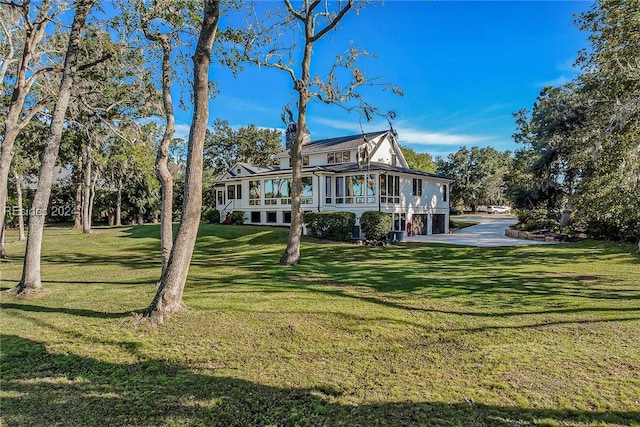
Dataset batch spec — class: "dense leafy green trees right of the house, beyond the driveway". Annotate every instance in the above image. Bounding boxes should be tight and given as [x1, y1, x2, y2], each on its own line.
[436, 0, 640, 247]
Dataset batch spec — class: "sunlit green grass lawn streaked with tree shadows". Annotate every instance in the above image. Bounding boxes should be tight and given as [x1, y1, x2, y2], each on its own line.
[0, 224, 640, 427]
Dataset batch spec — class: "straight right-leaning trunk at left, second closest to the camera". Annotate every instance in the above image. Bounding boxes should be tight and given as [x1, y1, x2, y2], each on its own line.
[16, 0, 95, 295]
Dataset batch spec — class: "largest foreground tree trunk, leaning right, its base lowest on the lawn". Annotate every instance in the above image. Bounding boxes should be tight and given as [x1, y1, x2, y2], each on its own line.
[144, 0, 220, 324]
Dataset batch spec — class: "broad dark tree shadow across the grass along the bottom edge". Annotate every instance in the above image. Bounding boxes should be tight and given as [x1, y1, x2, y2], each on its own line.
[0, 335, 640, 427]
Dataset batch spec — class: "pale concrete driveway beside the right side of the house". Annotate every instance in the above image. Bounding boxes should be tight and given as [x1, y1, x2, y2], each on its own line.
[404, 214, 553, 247]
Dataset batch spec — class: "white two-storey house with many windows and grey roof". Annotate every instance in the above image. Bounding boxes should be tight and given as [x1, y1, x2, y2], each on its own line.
[216, 128, 453, 234]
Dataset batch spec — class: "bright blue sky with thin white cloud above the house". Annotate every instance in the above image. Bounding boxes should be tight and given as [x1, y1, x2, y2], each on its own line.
[171, 0, 593, 157]
